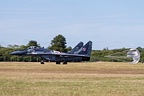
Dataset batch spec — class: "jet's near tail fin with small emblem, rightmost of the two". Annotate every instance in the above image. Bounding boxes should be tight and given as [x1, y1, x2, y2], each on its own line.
[77, 41, 92, 57]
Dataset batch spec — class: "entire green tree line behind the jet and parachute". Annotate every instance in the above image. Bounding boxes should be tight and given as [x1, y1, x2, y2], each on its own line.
[0, 35, 144, 62]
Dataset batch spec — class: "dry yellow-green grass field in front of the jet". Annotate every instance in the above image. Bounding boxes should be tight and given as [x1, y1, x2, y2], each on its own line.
[0, 62, 144, 96]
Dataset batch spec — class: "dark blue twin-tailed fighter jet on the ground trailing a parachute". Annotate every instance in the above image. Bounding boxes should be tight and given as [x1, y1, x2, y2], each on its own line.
[10, 41, 92, 64]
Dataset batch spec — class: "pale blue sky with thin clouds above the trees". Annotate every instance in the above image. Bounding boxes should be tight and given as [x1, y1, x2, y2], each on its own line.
[0, 0, 144, 50]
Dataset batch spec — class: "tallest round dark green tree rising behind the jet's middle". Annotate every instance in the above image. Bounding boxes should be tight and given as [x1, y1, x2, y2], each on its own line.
[48, 35, 67, 52]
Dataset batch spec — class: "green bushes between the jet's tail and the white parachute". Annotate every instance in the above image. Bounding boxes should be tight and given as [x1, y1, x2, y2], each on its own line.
[91, 48, 131, 62]
